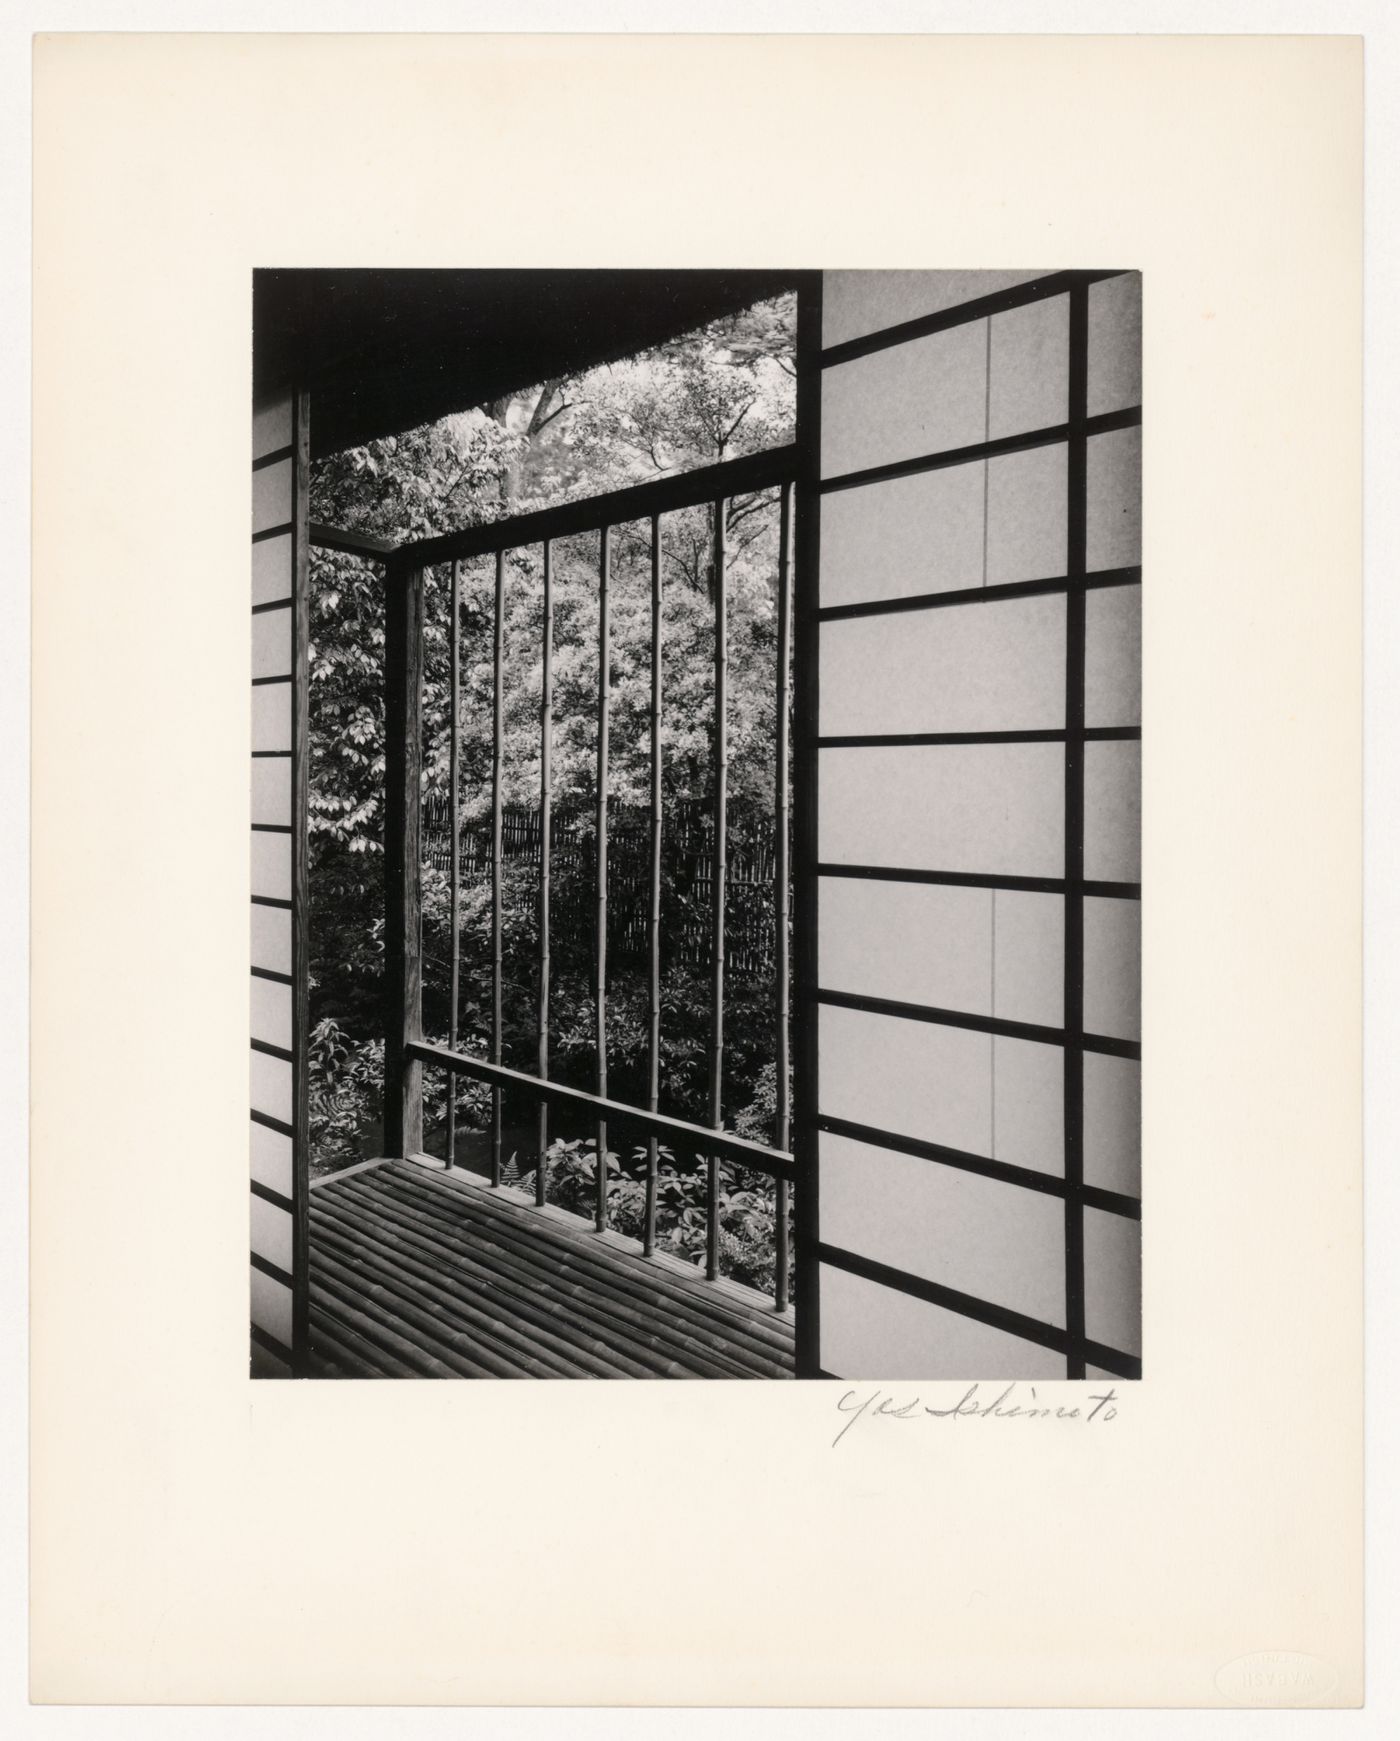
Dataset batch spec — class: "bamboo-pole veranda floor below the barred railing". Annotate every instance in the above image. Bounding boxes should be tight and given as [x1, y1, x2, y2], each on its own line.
[310, 1161, 792, 1379]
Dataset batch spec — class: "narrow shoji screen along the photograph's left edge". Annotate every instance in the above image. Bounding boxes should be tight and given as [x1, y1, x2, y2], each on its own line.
[249, 393, 310, 1377]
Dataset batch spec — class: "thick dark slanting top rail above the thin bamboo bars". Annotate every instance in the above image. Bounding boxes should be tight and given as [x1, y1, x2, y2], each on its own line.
[388, 446, 798, 568]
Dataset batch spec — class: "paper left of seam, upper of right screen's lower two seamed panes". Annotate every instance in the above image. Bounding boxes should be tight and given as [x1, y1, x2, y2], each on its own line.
[817, 877, 994, 1016]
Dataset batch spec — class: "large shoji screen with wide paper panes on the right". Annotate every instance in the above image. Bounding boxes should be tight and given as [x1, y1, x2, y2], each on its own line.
[815, 272, 1141, 1379]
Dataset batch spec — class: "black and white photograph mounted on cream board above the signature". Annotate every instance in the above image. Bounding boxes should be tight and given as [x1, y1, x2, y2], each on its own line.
[249, 265, 1142, 1381]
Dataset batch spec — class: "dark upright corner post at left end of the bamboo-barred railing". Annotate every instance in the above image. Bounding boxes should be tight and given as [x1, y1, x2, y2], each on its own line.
[383, 562, 423, 1158]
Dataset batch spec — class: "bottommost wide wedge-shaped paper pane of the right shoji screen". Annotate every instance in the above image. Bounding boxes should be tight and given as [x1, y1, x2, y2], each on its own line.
[820, 1264, 1066, 1378]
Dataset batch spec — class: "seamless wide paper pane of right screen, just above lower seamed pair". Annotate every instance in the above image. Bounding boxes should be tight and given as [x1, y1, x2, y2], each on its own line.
[817, 743, 1065, 876]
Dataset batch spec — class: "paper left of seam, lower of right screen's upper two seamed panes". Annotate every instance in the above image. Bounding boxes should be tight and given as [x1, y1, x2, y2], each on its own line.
[822, 460, 987, 604]
